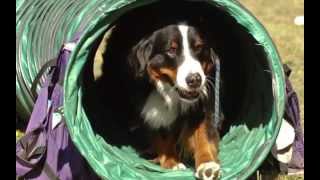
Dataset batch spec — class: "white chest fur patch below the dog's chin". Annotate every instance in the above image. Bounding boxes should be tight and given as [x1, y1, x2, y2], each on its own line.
[141, 89, 179, 129]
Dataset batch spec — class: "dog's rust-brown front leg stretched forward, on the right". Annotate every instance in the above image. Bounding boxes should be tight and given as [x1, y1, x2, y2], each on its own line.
[184, 119, 220, 180]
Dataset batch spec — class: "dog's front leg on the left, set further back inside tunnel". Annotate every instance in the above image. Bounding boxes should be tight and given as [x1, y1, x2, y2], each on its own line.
[153, 135, 186, 170]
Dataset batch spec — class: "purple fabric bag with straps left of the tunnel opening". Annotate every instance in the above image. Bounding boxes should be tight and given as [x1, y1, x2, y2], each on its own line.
[16, 34, 99, 180]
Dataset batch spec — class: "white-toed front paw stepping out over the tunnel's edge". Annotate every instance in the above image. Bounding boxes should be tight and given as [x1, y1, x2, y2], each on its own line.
[195, 161, 220, 180]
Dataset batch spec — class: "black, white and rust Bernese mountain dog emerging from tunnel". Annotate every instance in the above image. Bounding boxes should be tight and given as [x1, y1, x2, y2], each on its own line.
[134, 23, 219, 177]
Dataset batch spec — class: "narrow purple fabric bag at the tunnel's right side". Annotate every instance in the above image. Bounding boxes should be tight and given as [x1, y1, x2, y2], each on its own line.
[284, 65, 304, 173]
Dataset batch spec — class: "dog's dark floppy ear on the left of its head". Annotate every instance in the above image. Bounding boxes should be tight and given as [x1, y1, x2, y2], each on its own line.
[129, 39, 152, 78]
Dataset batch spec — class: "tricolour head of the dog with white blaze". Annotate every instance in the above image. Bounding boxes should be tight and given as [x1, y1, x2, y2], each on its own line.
[131, 24, 214, 103]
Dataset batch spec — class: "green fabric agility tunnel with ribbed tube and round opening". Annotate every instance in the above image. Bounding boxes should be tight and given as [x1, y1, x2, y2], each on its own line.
[16, 0, 285, 180]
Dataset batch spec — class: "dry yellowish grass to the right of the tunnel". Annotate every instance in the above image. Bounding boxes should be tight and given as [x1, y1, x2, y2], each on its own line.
[239, 0, 304, 180]
